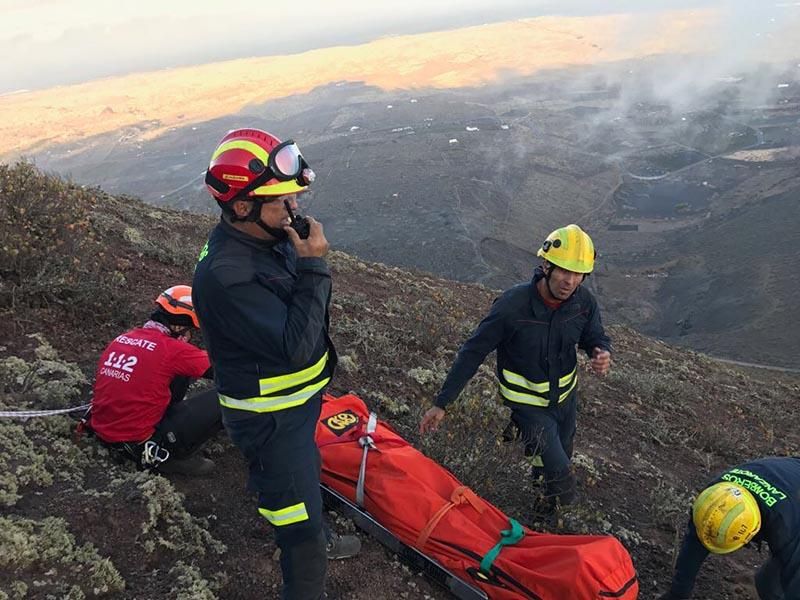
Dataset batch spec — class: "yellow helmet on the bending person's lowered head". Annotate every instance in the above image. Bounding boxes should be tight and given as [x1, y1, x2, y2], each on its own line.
[692, 481, 761, 554]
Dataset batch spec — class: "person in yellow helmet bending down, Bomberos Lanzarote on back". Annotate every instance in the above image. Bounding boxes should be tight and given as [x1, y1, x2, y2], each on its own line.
[660, 457, 800, 600]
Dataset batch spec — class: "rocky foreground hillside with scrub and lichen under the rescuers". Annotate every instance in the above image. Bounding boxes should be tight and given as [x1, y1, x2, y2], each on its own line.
[0, 164, 800, 600]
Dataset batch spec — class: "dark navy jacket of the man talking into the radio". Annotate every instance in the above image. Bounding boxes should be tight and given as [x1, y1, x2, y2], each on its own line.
[192, 221, 337, 398]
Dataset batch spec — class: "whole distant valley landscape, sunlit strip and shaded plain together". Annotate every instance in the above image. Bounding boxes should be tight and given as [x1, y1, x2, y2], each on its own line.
[0, 9, 800, 367]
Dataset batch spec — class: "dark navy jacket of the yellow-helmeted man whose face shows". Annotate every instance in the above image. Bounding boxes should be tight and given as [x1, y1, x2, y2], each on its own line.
[435, 269, 611, 408]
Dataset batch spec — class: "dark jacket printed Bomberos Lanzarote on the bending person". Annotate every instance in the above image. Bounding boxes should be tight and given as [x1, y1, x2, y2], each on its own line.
[672, 456, 800, 600]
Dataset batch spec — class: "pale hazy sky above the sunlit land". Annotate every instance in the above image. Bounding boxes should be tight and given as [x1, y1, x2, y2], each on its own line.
[0, 0, 800, 94]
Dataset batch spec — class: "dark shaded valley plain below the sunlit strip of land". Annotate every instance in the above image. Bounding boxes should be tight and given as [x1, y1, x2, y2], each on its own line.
[21, 56, 800, 367]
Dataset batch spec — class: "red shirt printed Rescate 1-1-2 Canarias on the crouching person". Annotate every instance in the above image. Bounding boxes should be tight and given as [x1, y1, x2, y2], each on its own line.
[89, 322, 210, 443]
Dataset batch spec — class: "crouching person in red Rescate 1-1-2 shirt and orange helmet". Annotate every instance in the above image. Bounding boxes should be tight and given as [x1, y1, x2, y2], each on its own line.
[88, 285, 222, 475]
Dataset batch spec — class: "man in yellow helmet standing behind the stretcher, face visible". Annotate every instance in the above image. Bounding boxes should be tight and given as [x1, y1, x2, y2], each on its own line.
[420, 225, 611, 511]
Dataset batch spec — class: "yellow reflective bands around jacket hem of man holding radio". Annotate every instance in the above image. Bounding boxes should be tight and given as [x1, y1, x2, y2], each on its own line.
[219, 352, 331, 412]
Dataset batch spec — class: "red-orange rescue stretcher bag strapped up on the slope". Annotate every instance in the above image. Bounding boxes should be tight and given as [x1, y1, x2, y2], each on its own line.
[316, 394, 639, 600]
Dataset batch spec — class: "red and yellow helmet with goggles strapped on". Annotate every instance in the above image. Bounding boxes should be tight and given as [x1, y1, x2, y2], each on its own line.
[206, 129, 314, 206]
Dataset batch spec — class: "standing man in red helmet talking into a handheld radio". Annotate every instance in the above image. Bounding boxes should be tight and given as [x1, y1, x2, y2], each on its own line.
[193, 129, 360, 600]
